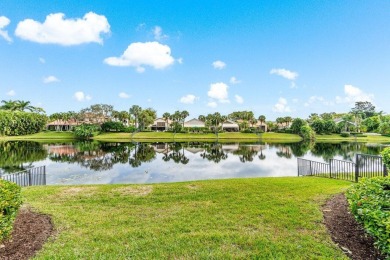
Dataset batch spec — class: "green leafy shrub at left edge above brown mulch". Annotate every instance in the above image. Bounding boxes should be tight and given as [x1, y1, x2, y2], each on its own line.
[0, 179, 22, 241]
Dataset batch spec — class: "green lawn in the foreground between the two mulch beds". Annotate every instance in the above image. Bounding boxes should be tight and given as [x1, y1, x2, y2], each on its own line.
[23, 177, 350, 259]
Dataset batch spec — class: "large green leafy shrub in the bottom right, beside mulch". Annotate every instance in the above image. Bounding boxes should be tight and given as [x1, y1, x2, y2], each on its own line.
[346, 177, 390, 256]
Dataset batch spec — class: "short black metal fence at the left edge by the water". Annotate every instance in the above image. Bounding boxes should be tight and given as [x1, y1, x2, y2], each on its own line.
[0, 166, 46, 187]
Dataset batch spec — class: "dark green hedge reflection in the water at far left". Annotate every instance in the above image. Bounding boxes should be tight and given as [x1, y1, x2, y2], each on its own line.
[0, 141, 47, 173]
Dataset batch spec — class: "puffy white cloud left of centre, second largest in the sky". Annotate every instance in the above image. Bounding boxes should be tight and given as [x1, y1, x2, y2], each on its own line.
[104, 42, 175, 73]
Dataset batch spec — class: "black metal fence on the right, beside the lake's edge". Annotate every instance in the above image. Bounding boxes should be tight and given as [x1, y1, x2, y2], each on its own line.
[298, 154, 388, 182]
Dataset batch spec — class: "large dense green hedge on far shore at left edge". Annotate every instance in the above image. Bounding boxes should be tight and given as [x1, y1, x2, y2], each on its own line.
[0, 110, 47, 136]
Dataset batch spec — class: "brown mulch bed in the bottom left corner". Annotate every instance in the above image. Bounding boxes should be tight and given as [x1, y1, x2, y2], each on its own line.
[0, 207, 53, 260]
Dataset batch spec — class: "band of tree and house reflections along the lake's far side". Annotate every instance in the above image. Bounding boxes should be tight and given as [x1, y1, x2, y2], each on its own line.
[0, 141, 383, 172]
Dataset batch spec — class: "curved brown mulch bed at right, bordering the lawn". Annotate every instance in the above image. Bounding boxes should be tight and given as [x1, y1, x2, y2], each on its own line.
[323, 194, 385, 260]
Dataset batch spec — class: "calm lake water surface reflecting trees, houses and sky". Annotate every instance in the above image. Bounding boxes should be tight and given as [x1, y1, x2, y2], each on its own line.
[0, 141, 387, 185]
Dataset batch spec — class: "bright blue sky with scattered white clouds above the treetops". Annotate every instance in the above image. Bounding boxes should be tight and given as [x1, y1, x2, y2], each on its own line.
[0, 0, 390, 119]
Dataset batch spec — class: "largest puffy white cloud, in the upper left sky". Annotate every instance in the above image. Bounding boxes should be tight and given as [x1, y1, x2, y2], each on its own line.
[15, 12, 110, 46]
